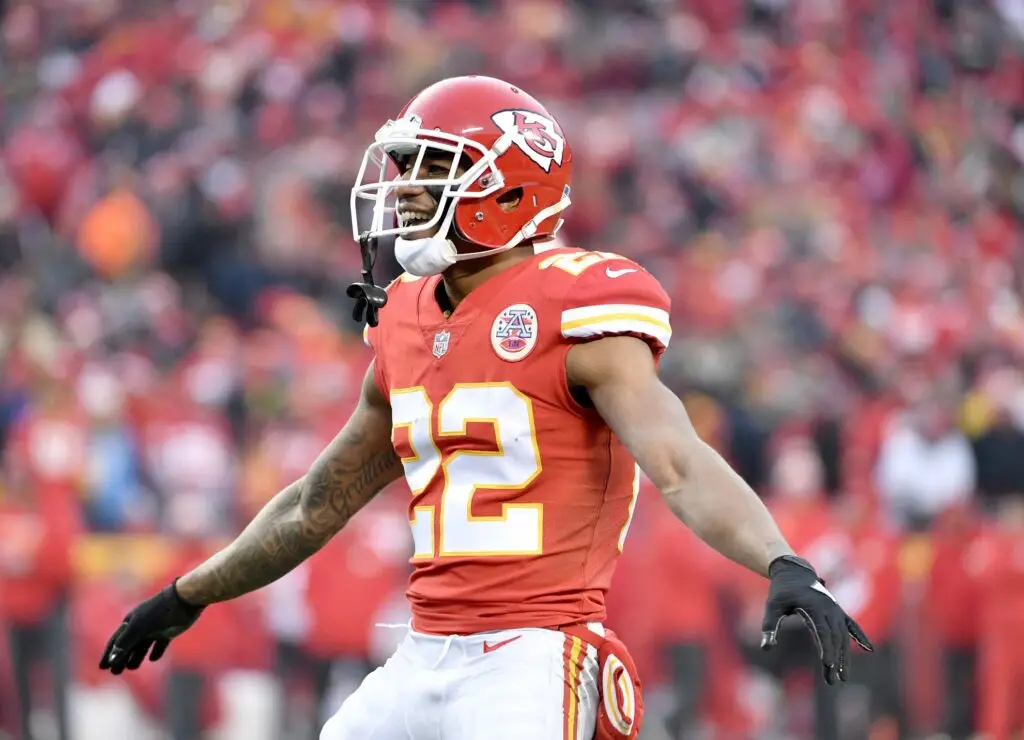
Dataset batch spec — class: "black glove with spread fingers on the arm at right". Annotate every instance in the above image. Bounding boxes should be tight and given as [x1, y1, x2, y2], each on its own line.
[761, 555, 874, 684]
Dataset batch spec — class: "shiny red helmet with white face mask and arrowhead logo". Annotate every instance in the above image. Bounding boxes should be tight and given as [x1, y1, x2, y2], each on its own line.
[351, 76, 572, 256]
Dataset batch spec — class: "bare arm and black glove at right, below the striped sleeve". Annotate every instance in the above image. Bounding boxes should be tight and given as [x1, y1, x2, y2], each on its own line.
[566, 336, 870, 684]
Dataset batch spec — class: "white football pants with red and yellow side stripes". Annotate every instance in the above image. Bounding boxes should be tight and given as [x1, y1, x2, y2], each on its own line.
[321, 624, 601, 740]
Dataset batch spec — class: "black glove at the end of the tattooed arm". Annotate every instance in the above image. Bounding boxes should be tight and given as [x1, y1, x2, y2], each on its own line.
[99, 583, 204, 676]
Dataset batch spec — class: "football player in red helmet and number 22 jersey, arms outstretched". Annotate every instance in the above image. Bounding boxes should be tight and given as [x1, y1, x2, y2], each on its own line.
[100, 77, 870, 740]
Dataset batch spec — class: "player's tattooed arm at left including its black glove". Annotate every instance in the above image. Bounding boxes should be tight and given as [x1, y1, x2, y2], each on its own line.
[99, 363, 401, 673]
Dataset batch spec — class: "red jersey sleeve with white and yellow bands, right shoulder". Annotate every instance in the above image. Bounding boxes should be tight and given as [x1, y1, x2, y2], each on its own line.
[561, 258, 672, 357]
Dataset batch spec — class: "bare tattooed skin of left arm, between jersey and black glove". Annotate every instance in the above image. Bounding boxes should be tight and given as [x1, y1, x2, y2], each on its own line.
[178, 372, 401, 604]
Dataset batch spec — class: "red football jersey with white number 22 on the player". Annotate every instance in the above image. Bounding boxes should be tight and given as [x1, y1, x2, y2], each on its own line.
[367, 249, 672, 634]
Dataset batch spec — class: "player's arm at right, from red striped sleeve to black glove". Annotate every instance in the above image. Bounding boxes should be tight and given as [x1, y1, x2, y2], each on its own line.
[552, 254, 870, 684]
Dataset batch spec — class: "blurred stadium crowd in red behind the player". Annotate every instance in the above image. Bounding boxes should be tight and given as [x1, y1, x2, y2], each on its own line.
[0, 0, 1024, 739]
